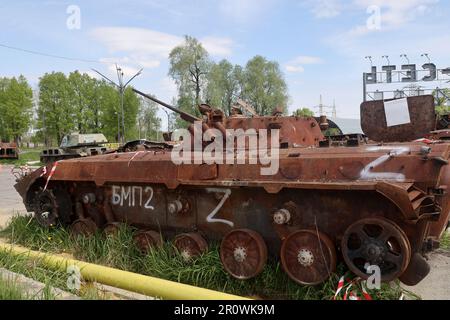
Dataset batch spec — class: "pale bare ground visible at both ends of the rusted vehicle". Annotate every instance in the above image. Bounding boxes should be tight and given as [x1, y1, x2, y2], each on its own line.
[0, 166, 450, 300]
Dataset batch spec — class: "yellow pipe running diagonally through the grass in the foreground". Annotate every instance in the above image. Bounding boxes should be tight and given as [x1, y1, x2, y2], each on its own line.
[0, 243, 247, 300]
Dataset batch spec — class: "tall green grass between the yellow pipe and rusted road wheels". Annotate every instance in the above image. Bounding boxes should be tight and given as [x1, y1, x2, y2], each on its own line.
[0, 217, 416, 300]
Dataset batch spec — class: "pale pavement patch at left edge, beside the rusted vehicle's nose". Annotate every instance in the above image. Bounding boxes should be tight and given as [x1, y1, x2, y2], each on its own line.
[0, 165, 26, 226]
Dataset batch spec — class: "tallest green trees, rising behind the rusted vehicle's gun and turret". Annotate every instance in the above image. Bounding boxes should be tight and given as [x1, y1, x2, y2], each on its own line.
[169, 36, 288, 122]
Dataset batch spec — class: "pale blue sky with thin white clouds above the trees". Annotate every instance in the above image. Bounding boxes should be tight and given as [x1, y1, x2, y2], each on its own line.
[0, 0, 450, 124]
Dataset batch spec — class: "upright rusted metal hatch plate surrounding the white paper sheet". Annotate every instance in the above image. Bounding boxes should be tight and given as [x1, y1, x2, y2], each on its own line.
[361, 95, 436, 142]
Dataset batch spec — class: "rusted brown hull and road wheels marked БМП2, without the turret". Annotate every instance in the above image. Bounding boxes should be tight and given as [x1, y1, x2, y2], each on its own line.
[16, 143, 450, 284]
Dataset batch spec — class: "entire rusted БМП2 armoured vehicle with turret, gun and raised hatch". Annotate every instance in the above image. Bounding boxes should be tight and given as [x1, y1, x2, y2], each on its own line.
[15, 90, 450, 285]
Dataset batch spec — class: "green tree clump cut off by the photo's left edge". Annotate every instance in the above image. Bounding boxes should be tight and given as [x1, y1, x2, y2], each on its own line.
[0, 76, 33, 142]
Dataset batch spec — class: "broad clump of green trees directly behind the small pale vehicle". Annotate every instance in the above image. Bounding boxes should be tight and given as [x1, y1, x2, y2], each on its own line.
[37, 71, 140, 145]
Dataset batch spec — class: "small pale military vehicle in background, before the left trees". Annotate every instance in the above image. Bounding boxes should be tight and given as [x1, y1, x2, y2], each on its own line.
[40, 133, 108, 163]
